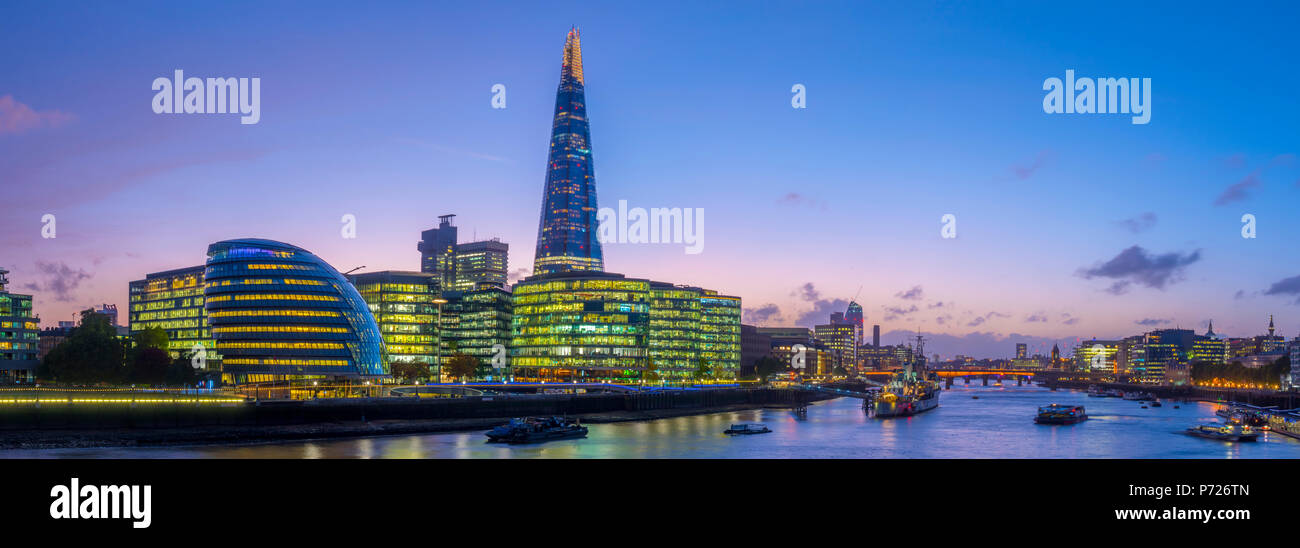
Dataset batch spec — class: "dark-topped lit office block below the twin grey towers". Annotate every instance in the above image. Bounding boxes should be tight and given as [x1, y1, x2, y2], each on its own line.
[439, 287, 514, 380]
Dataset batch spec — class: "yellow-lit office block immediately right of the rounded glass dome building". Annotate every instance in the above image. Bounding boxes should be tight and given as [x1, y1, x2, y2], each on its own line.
[348, 270, 441, 379]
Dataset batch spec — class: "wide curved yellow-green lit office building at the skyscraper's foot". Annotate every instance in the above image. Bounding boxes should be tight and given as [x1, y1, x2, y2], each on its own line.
[511, 273, 741, 382]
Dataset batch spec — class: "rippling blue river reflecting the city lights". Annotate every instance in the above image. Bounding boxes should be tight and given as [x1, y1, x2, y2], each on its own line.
[0, 383, 1300, 458]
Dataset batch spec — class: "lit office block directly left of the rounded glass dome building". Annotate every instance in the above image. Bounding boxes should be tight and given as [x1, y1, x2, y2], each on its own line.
[127, 266, 221, 371]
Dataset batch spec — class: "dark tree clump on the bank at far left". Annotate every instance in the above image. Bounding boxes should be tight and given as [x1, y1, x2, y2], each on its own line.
[36, 310, 126, 384]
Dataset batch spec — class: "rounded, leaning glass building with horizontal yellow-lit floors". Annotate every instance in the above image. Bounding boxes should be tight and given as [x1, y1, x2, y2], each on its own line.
[203, 239, 389, 383]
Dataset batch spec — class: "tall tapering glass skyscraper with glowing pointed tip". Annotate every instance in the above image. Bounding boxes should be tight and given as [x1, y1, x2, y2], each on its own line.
[533, 27, 605, 275]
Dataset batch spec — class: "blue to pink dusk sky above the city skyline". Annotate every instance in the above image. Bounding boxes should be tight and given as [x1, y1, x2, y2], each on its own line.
[0, 1, 1300, 357]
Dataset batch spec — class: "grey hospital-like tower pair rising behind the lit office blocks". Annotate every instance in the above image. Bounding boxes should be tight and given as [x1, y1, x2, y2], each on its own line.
[416, 214, 510, 291]
